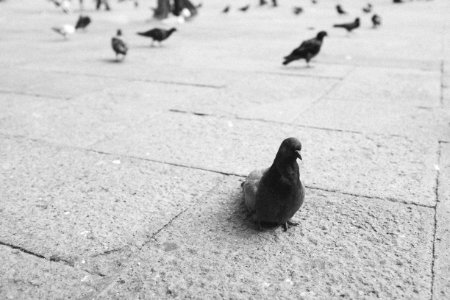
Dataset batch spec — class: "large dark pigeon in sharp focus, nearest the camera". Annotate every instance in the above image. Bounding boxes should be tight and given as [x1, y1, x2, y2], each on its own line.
[242, 137, 305, 231]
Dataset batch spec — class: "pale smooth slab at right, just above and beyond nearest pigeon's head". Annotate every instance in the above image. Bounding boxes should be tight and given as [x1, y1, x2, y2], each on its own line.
[293, 98, 450, 139]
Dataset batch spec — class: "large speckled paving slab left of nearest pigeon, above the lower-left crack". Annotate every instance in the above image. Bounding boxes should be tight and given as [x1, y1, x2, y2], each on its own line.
[0, 136, 224, 274]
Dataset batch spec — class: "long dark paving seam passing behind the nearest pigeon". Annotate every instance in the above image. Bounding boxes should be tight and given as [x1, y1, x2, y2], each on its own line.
[0, 132, 434, 208]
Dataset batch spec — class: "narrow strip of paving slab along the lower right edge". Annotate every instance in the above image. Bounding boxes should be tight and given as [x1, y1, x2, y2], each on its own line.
[433, 143, 450, 300]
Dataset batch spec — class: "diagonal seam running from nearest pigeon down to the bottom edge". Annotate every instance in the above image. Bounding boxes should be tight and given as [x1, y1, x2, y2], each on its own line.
[90, 178, 227, 299]
